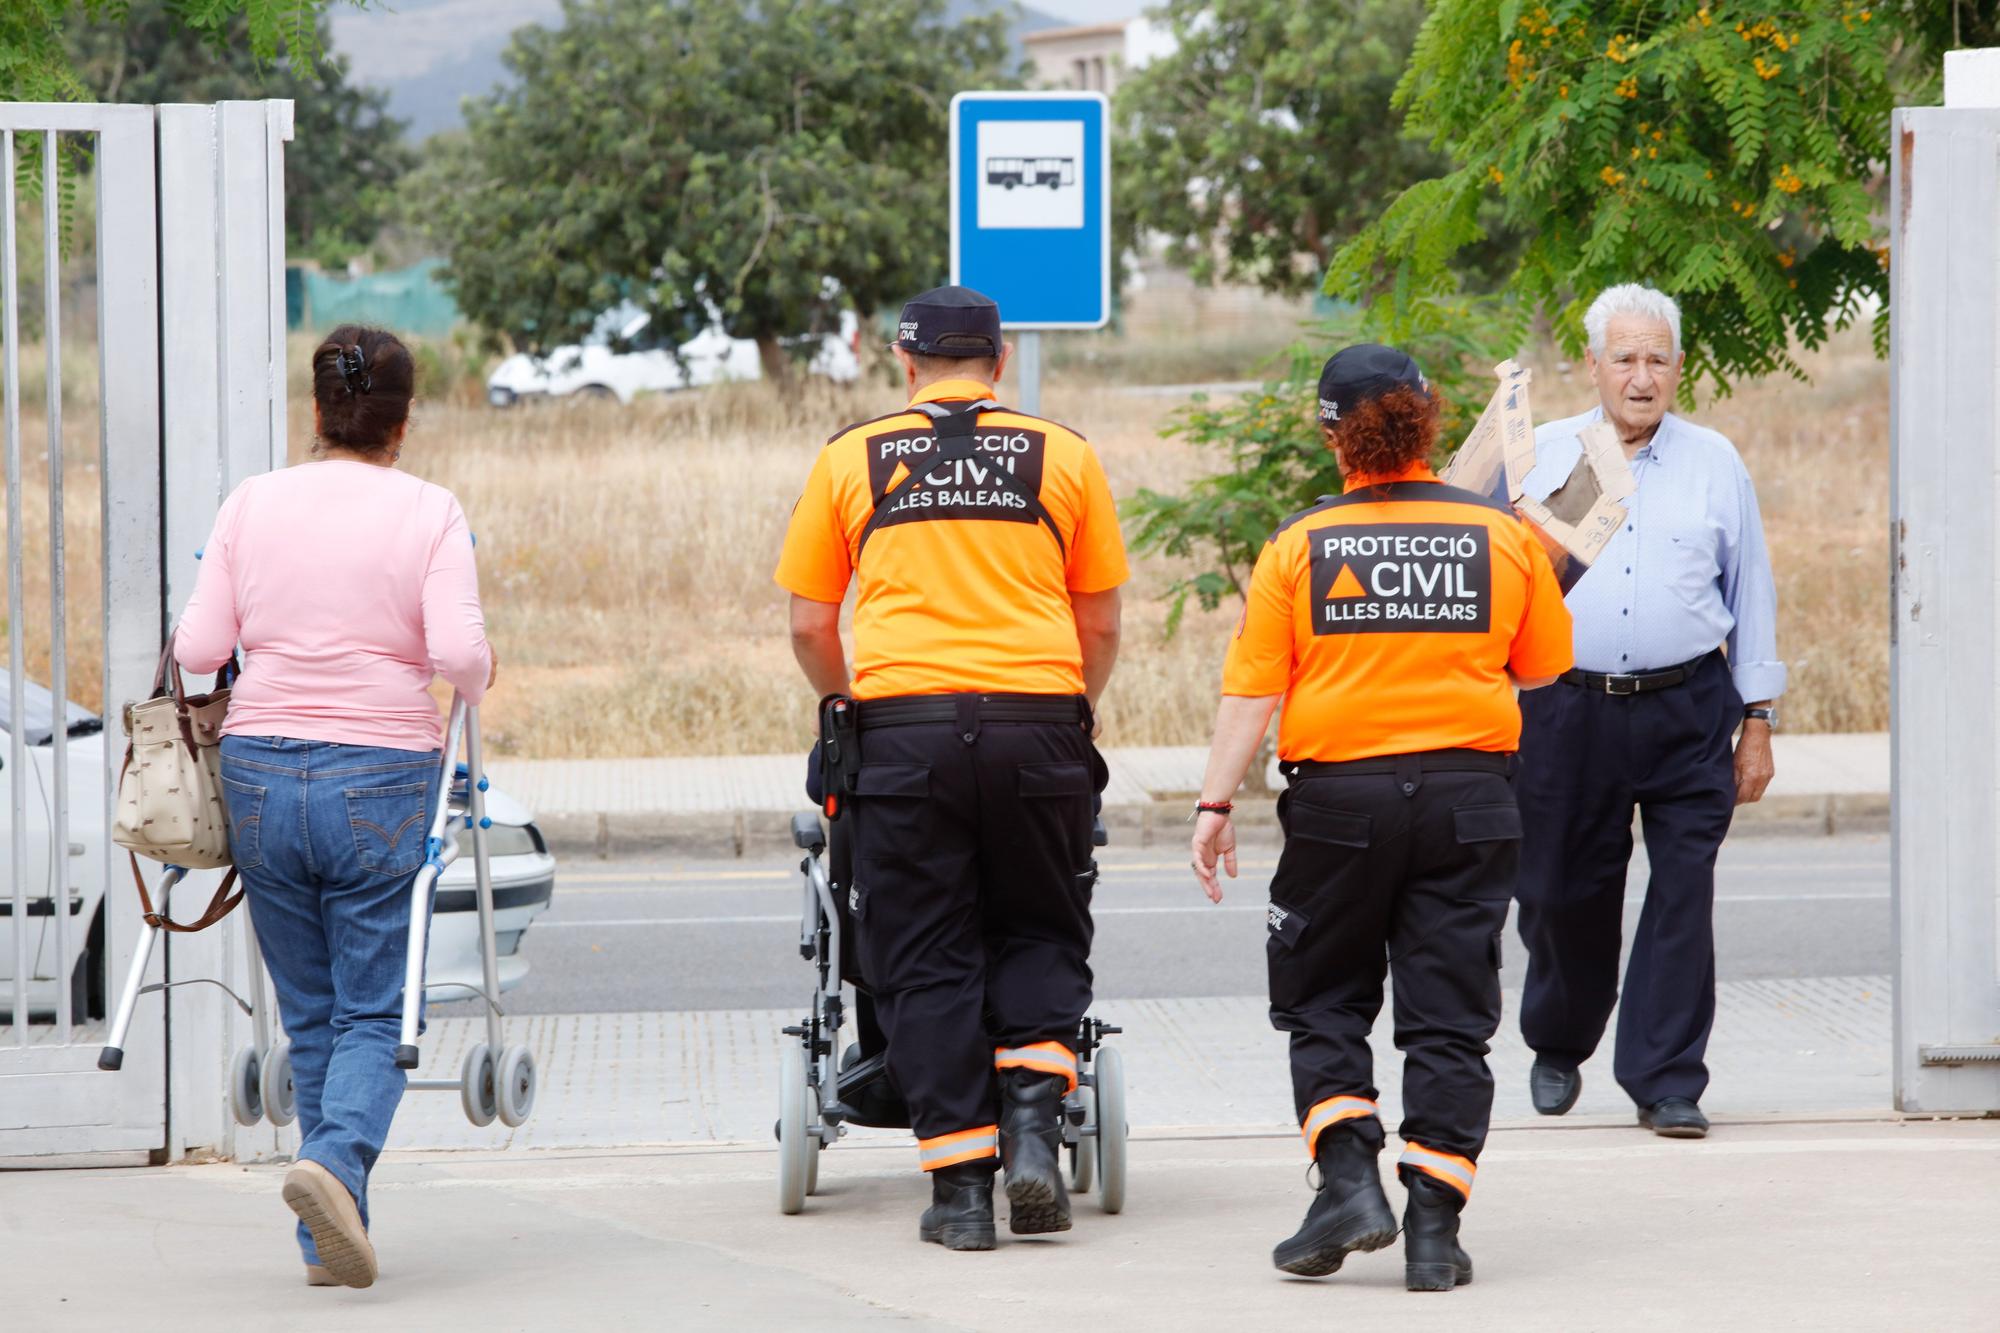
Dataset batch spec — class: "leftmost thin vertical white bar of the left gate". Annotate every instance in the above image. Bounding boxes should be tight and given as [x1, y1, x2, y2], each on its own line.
[0, 130, 28, 1047]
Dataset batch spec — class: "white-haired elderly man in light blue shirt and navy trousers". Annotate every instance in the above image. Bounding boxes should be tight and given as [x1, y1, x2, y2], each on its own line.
[1516, 284, 1784, 1139]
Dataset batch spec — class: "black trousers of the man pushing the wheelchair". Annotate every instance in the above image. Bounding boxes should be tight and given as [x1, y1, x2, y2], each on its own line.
[848, 723, 1104, 1141]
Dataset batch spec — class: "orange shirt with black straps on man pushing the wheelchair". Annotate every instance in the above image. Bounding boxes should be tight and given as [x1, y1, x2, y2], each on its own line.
[776, 380, 1128, 699]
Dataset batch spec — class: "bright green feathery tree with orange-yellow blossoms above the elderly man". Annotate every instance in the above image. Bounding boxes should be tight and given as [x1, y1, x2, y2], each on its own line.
[1326, 0, 1952, 394]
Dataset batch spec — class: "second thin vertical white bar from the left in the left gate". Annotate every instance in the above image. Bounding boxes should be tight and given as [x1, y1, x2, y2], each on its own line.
[45, 130, 71, 1043]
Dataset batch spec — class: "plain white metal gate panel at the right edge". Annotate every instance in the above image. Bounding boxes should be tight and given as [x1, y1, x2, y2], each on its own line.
[1896, 88, 2000, 1113]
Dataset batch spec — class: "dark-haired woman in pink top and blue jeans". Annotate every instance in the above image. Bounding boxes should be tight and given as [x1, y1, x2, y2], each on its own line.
[174, 324, 498, 1287]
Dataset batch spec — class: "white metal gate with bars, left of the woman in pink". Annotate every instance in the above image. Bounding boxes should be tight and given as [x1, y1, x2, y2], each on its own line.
[0, 102, 292, 1161]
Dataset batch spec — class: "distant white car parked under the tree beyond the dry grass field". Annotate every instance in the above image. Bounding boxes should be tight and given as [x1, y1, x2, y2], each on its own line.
[486, 304, 860, 408]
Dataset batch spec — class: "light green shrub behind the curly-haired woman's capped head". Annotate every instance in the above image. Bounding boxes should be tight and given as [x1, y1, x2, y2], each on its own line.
[1124, 296, 1528, 634]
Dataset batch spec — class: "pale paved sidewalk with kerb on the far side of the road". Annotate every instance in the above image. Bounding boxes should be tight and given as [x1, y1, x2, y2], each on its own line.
[488, 733, 1890, 857]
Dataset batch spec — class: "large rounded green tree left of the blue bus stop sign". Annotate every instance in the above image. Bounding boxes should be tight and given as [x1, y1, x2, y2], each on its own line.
[426, 0, 1008, 366]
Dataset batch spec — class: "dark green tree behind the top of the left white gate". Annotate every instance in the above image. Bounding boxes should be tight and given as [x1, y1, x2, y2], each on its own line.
[68, 0, 414, 266]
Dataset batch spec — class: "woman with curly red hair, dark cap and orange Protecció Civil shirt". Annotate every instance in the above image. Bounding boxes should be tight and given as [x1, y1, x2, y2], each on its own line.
[1192, 344, 1570, 1291]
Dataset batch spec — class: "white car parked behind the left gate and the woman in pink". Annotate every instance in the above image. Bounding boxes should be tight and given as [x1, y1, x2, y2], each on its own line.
[0, 671, 556, 1023]
